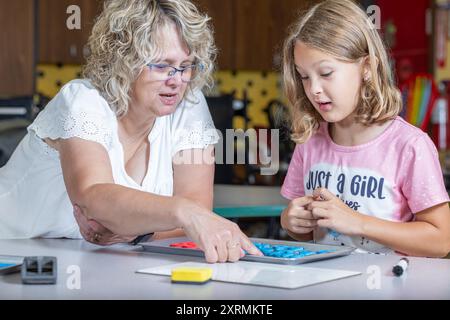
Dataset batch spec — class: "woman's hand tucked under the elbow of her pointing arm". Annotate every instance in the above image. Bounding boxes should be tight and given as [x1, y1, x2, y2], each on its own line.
[73, 205, 136, 246]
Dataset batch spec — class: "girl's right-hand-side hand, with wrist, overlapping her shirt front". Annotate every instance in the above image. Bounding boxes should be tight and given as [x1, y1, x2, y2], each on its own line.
[309, 188, 364, 236]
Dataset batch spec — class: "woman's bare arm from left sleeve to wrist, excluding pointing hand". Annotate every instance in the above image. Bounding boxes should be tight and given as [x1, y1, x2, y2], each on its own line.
[57, 138, 180, 236]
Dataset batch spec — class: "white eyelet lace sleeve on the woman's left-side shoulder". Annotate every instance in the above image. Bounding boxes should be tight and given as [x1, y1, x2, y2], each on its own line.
[28, 82, 115, 150]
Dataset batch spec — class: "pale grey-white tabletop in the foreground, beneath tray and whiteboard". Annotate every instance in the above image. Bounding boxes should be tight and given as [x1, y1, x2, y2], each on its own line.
[0, 239, 450, 300]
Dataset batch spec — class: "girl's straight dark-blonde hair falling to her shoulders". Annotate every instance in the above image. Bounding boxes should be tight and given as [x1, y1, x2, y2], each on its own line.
[283, 0, 402, 143]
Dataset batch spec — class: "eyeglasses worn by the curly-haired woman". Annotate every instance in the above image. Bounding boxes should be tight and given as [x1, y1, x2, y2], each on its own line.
[147, 63, 203, 82]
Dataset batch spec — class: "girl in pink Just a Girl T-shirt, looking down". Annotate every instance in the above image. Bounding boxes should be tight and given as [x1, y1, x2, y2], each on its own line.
[281, 0, 450, 257]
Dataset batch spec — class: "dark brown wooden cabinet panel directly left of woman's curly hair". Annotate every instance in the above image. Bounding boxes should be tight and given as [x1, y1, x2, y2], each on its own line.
[38, 0, 103, 64]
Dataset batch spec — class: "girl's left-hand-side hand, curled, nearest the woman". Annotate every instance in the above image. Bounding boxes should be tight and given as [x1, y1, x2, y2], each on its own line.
[281, 196, 317, 234]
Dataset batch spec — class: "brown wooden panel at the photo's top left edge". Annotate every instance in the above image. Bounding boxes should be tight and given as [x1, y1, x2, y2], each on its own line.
[0, 0, 35, 99]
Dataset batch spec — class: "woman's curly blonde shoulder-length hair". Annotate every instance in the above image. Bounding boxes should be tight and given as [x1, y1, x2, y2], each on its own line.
[83, 0, 216, 117]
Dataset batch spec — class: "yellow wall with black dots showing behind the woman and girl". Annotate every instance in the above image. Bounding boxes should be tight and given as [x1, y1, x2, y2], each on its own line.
[36, 64, 282, 128]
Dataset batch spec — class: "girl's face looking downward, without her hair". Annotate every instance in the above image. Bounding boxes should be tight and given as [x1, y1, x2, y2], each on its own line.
[294, 41, 363, 123]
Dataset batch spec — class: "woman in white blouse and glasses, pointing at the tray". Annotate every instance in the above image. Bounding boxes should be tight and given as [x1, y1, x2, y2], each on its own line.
[0, 0, 260, 262]
